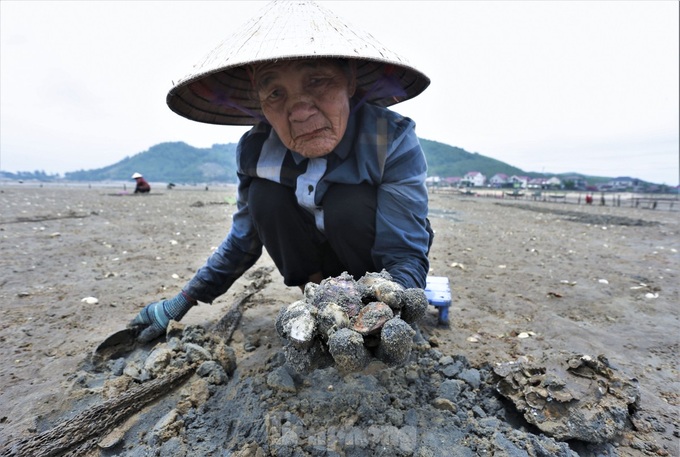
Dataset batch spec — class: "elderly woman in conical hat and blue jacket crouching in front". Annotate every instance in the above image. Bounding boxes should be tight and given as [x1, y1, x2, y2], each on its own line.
[131, 2, 433, 341]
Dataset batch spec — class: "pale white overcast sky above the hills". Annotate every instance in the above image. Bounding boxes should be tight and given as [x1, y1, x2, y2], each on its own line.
[0, 0, 680, 185]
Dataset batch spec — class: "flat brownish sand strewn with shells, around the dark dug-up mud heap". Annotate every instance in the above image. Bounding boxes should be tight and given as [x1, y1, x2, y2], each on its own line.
[0, 185, 680, 456]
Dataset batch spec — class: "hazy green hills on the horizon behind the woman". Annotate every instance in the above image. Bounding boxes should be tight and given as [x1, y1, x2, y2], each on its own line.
[0, 138, 624, 184]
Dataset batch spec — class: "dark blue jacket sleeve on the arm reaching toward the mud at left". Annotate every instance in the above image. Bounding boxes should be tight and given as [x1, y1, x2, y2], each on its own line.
[183, 134, 262, 303]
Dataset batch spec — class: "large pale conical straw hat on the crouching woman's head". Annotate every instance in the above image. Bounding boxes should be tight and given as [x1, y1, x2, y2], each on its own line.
[167, 1, 430, 125]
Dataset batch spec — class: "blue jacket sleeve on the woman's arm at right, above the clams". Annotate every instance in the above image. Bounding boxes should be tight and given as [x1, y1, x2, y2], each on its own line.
[373, 118, 431, 288]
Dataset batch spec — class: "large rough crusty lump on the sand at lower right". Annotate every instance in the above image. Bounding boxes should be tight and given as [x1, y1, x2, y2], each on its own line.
[493, 352, 640, 443]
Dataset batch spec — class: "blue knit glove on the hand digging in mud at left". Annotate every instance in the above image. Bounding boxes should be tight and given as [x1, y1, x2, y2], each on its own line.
[128, 292, 196, 343]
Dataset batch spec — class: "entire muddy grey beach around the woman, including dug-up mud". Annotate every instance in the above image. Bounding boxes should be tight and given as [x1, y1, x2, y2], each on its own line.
[0, 184, 680, 456]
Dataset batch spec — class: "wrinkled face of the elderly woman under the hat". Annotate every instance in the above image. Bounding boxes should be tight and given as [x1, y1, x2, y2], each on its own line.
[253, 59, 355, 158]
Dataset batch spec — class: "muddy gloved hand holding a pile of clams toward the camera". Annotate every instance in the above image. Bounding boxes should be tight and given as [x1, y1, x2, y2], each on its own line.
[276, 270, 428, 373]
